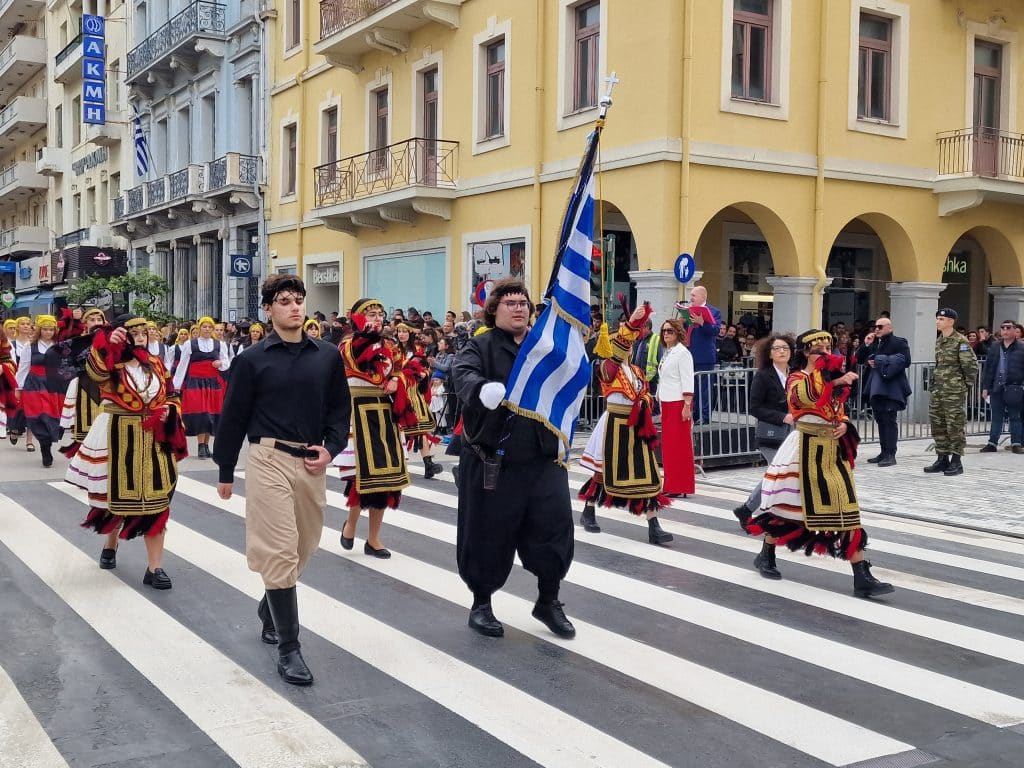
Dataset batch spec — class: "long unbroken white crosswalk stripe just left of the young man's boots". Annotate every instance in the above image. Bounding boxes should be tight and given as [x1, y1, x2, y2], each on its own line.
[0, 493, 366, 768]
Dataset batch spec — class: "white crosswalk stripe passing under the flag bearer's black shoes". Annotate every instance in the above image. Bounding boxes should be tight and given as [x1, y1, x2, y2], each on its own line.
[178, 478, 913, 766]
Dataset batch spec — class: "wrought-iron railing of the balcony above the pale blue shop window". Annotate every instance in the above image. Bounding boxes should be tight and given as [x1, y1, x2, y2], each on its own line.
[313, 138, 459, 208]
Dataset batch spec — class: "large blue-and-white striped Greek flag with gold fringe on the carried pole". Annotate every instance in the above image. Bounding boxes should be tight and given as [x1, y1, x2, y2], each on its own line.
[505, 128, 600, 461]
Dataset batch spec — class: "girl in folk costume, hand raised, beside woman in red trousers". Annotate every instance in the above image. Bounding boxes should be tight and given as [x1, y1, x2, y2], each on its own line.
[580, 303, 672, 545]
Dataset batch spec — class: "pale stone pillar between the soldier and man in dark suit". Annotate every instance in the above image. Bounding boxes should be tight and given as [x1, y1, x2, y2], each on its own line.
[887, 283, 946, 422]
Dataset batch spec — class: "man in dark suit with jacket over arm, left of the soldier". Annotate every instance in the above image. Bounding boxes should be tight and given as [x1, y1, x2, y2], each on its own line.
[857, 316, 910, 467]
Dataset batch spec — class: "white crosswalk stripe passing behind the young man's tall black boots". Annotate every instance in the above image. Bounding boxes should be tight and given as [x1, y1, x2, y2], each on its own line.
[56, 476, 668, 768]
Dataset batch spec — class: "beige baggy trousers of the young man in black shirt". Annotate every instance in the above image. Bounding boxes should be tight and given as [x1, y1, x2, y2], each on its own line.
[246, 438, 327, 590]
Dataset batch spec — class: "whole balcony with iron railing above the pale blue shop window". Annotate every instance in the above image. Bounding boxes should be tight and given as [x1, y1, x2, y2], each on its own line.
[313, 138, 459, 231]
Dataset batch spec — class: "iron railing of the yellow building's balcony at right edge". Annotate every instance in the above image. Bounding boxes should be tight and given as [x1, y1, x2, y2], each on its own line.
[938, 128, 1024, 180]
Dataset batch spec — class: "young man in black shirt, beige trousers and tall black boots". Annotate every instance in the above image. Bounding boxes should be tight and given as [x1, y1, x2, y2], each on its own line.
[213, 274, 351, 685]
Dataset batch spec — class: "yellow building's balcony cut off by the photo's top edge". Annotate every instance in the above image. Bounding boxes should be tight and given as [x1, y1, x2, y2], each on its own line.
[313, 0, 466, 72]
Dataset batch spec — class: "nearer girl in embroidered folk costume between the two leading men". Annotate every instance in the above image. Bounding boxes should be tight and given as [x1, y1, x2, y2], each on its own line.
[334, 299, 410, 558]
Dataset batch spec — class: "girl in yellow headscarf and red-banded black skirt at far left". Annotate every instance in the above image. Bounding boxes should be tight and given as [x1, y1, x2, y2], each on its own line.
[17, 314, 67, 467]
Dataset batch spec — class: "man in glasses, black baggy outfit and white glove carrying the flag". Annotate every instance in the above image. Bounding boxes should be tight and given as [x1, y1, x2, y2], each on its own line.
[453, 278, 575, 638]
